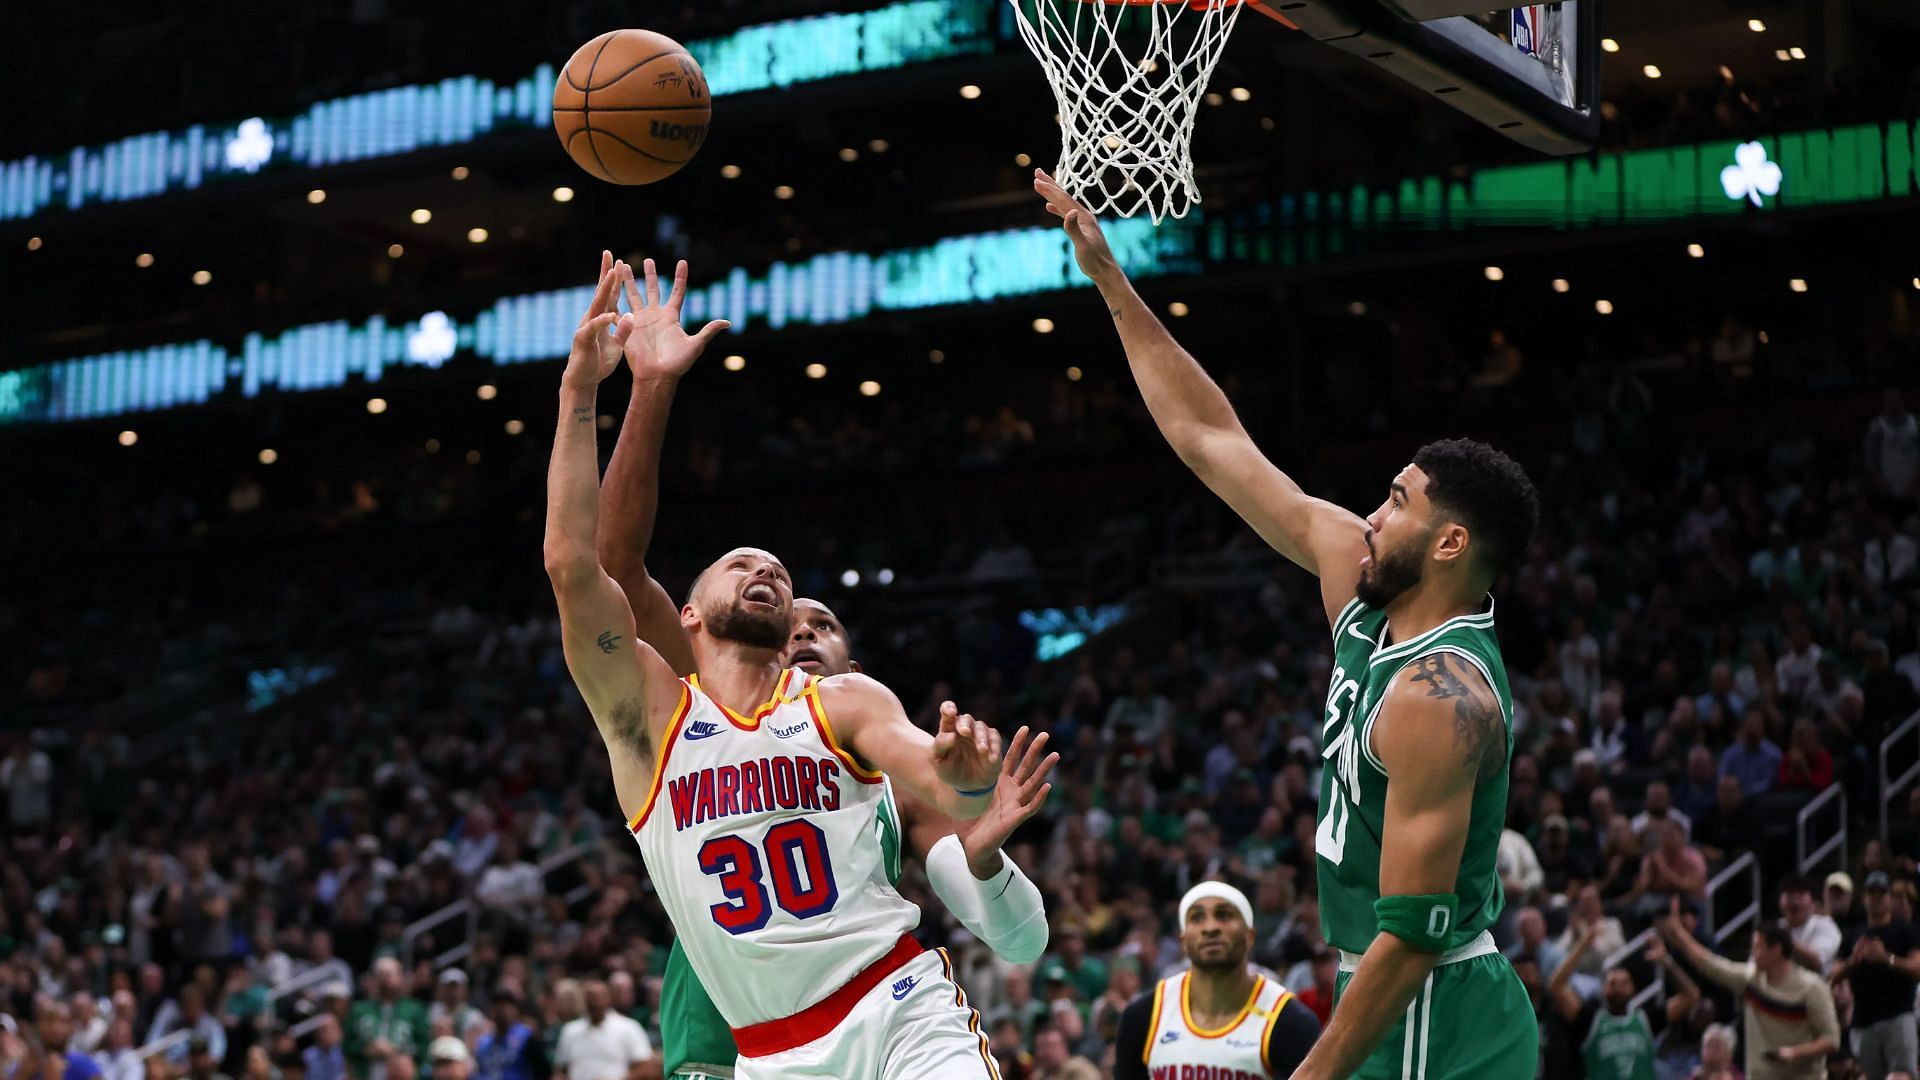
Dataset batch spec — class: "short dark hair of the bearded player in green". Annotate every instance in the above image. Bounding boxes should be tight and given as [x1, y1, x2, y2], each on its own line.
[1413, 438, 1540, 577]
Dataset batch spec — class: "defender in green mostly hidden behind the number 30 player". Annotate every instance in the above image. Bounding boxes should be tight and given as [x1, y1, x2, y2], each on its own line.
[599, 259, 1060, 1080]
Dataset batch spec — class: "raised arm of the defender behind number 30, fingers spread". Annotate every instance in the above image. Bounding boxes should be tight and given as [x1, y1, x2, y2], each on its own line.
[599, 252, 732, 675]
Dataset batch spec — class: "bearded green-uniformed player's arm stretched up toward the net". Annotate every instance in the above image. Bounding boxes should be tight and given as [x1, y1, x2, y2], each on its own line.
[1033, 169, 1367, 623]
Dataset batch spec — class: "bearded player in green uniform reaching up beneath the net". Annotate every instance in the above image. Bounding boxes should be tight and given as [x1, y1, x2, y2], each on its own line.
[1033, 171, 1540, 1080]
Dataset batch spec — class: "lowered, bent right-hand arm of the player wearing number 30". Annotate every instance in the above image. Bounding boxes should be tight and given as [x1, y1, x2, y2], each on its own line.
[818, 673, 1006, 821]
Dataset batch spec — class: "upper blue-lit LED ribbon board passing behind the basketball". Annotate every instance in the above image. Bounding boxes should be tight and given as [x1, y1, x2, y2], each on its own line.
[0, 0, 996, 221]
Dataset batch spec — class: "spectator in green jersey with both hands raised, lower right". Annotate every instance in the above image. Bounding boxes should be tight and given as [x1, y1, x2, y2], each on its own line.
[1548, 914, 1699, 1080]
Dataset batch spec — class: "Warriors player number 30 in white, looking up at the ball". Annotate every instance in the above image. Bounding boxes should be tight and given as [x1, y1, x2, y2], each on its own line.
[543, 256, 1000, 1080]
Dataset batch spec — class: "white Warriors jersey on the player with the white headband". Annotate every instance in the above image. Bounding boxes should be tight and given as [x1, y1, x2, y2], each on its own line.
[1146, 970, 1306, 1080]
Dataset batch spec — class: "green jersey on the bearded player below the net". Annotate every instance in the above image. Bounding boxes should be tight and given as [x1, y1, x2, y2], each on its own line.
[1313, 600, 1513, 953]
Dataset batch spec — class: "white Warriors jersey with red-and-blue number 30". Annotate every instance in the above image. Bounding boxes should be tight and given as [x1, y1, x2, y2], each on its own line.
[630, 669, 920, 1028]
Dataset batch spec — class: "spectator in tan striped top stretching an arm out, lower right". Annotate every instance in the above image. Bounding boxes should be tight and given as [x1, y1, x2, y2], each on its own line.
[1661, 907, 1839, 1080]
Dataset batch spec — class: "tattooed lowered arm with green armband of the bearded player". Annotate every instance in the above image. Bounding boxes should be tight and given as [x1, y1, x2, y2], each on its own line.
[1294, 653, 1507, 1080]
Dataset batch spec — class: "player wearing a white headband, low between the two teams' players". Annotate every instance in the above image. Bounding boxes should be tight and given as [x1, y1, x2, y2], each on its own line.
[1114, 882, 1319, 1080]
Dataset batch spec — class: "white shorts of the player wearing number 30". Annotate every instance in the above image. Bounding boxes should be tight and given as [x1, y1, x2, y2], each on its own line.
[733, 949, 1000, 1080]
